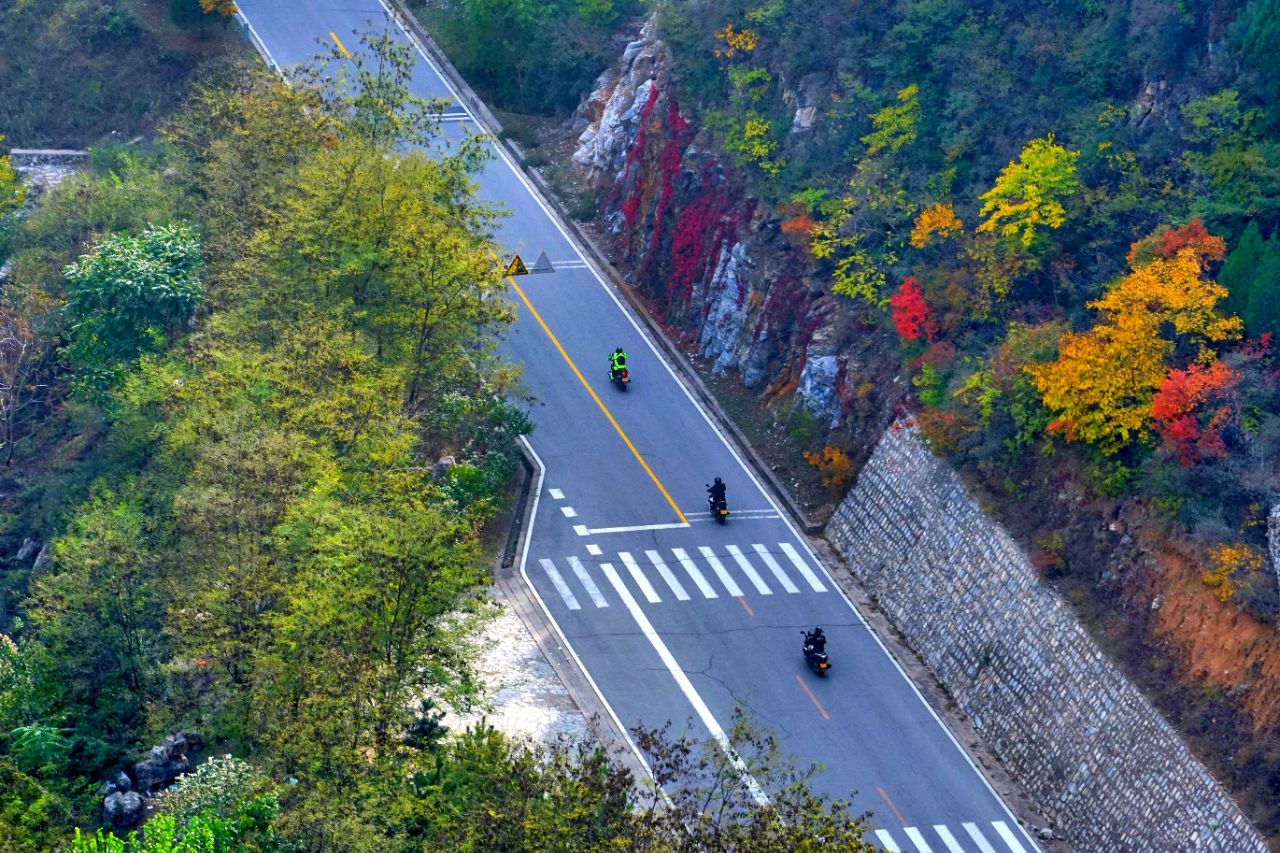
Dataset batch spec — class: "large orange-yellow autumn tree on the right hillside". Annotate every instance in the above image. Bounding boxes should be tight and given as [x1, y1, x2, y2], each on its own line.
[1029, 239, 1242, 455]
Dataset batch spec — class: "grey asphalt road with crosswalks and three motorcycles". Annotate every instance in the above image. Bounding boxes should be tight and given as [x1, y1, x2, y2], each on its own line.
[239, 0, 1037, 853]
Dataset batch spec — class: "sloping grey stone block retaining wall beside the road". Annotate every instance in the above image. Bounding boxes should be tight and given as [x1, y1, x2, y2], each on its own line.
[827, 428, 1267, 853]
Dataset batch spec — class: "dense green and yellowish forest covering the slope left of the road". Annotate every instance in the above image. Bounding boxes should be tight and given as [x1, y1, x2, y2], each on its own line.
[0, 3, 872, 853]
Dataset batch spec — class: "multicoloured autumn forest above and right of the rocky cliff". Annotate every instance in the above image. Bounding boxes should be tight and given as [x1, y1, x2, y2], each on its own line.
[637, 0, 1280, 617]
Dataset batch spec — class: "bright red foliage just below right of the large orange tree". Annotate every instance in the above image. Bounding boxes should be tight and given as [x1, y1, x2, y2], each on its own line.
[1151, 361, 1240, 467]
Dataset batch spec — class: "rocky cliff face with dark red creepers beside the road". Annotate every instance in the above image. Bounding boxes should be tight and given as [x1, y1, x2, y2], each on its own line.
[573, 24, 902, 445]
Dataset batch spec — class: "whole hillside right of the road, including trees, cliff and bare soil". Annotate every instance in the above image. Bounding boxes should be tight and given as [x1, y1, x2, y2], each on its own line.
[422, 0, 1280, 836]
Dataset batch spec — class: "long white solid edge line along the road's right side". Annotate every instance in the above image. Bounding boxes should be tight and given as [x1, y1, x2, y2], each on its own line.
[363, 0, 1039, 850]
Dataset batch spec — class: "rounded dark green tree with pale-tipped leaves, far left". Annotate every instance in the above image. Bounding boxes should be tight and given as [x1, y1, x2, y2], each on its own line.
[63, 224, 201, 393]
